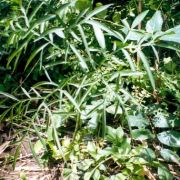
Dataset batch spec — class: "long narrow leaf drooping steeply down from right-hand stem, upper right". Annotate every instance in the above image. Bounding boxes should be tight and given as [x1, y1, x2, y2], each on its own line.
[137, 50, 155, 90]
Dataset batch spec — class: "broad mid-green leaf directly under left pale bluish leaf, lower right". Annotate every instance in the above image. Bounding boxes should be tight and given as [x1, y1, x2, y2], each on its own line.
[132, 129, 154, 141]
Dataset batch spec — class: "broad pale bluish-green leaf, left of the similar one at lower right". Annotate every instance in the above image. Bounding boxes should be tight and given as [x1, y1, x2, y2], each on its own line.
[128, 114, 149, 127]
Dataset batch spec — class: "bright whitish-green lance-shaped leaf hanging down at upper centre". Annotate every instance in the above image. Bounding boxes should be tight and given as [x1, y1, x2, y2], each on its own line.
[93, 25, 106, 49]
